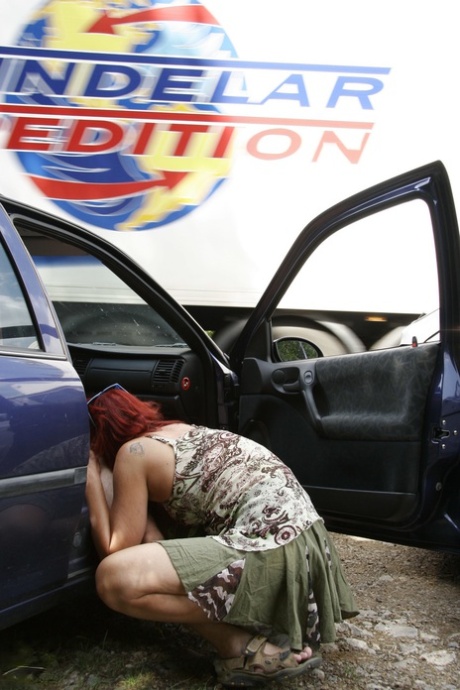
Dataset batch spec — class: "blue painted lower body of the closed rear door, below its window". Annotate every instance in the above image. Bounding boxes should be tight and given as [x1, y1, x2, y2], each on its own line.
[0, 356, 89, 607]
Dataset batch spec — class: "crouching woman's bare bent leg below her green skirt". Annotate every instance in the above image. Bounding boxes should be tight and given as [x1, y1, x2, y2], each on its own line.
[96, 543, 311, 663]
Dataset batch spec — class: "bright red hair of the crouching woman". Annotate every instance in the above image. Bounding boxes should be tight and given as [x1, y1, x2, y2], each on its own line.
[88, 388, 177, 469]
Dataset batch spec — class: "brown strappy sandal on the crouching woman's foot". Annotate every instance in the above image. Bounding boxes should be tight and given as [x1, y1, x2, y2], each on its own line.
[214, 635, 321, 687]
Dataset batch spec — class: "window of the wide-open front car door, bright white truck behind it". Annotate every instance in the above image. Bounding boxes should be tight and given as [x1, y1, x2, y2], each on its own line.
[280, 199, 439, 349]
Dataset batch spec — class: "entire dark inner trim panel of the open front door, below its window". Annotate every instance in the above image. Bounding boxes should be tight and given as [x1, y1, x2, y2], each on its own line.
[240, 344, 439, 523]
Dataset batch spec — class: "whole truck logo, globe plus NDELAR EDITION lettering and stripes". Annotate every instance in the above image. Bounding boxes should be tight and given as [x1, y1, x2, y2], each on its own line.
[0, 0, 389, 231]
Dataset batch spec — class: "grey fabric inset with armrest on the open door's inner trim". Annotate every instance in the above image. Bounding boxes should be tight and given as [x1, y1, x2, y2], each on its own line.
[302, 344, 439, 442]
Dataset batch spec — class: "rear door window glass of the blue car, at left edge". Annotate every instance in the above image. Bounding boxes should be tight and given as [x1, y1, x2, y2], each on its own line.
[0, 244, 39, 349]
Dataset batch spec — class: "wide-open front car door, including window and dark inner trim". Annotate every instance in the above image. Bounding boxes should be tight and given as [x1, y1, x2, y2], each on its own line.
[231, 162, 460, 551]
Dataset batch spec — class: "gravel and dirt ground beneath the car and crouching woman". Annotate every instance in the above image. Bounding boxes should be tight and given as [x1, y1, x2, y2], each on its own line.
[0, 535, 460, 690]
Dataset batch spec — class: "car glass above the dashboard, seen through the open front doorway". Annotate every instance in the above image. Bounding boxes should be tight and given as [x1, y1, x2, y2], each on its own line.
[21, 230, 184, 348]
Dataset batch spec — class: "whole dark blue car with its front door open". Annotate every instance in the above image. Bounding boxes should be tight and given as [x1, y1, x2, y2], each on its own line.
[0, 162, 460, 627]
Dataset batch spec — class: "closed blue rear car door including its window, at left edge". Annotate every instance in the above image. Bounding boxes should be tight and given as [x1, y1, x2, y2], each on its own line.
[0, 207, 89, 625]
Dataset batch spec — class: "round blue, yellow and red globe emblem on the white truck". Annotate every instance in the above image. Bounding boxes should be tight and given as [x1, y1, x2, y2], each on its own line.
[10, 0, 236, 231]
